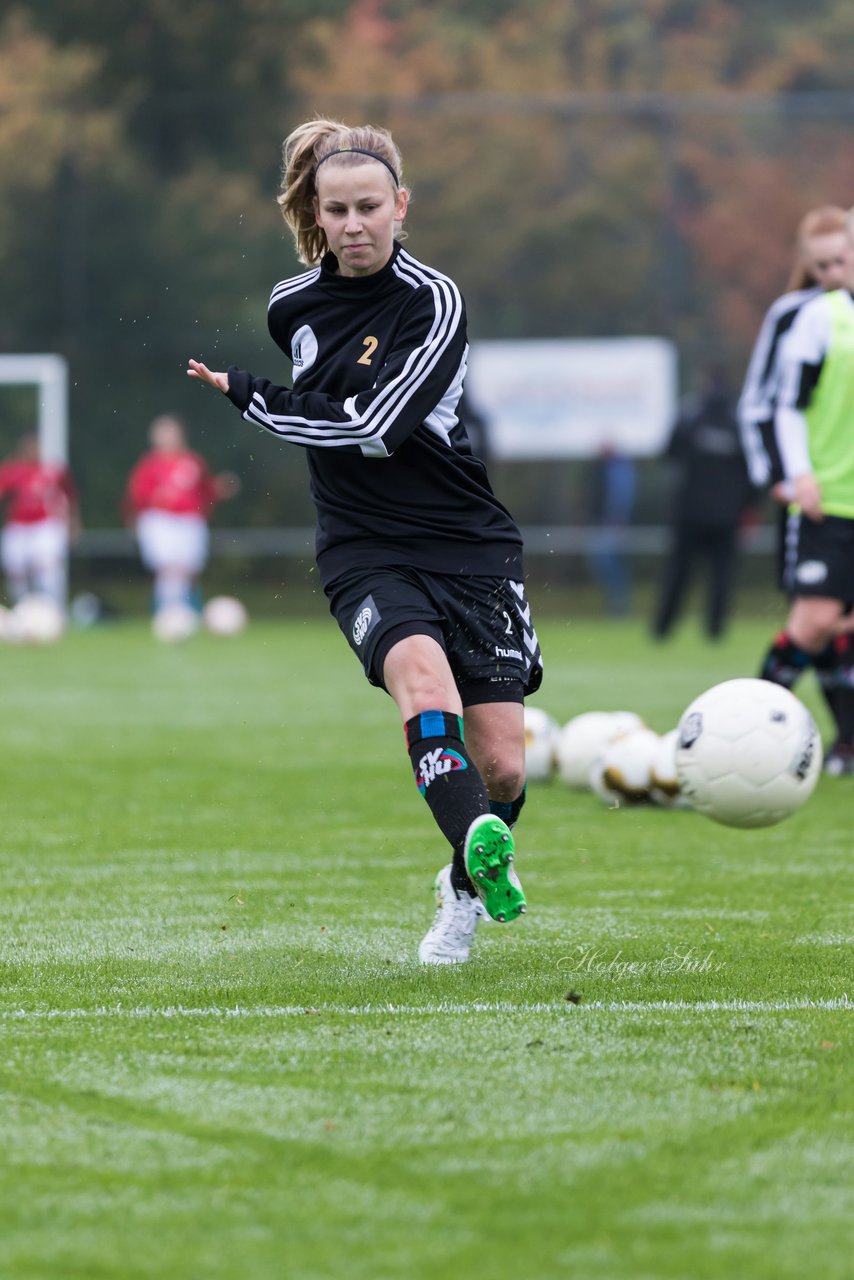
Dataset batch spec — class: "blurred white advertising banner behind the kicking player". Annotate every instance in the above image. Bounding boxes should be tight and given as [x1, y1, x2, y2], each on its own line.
[466, 338, 677, 458]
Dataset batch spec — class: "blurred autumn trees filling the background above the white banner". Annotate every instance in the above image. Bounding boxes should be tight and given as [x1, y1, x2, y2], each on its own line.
[0, 0, 854, 519]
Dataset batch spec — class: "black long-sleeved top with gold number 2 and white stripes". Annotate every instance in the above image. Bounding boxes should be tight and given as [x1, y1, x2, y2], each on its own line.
[228, 244, 522, 585]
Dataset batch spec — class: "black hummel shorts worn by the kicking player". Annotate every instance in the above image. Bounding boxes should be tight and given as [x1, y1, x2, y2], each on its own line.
[326, 564, 543, 707]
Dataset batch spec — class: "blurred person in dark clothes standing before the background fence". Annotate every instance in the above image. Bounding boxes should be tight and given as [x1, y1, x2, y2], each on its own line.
[653, 366, 758, 640]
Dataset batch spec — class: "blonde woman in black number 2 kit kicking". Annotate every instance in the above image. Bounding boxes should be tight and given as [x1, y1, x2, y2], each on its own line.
[188, 118, 542, 964]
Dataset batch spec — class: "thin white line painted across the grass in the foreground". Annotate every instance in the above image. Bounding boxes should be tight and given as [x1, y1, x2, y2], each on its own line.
[0, 995, 854, 1023]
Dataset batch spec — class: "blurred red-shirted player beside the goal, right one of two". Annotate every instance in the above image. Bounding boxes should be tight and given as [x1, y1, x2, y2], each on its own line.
[124, 415, 239, 613]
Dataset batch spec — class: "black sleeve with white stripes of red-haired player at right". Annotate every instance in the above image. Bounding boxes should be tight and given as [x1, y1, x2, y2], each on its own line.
[739, 285, 822, 488]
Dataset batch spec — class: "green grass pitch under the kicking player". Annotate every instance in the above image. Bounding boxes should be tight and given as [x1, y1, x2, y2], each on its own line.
[0, 620, 854, 1280]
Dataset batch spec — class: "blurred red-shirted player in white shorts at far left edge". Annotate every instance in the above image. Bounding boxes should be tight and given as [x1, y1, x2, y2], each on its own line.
[0, 433, 79, 609]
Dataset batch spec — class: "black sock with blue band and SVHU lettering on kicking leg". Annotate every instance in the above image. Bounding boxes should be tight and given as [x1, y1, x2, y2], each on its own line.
[405, 710, 489, 893]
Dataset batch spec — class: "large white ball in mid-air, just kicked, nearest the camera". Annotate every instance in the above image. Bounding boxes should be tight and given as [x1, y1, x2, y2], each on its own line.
[676, 678, 822, 827]
